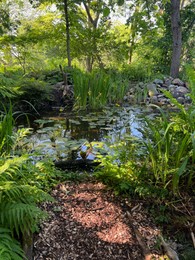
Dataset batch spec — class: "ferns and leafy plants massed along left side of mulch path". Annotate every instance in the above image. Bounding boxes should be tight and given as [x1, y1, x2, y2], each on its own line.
[0, 105, 61, 259]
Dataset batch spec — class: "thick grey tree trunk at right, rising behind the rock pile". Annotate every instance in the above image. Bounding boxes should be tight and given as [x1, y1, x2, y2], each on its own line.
[170, 0, 182, 78]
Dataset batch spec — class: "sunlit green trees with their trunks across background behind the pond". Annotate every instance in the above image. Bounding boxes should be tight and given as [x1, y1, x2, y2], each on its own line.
[0, 0, 195, 77]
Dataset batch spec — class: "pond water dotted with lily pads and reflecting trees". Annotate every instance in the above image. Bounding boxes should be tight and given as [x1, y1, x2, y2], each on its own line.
[21, 106, 155, 161]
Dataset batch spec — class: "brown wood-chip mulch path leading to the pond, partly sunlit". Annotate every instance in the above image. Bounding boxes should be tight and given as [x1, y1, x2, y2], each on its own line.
[33, 181, 165, 260]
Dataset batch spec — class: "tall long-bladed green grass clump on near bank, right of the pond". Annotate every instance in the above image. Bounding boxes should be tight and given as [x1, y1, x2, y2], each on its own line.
[143, 68, 195, 194]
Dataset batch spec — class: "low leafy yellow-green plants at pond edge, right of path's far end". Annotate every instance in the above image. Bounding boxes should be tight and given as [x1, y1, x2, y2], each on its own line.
[94, 138, 141, 193]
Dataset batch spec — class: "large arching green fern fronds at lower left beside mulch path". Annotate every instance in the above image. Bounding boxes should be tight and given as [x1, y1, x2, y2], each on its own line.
[0, 156, 51, 236]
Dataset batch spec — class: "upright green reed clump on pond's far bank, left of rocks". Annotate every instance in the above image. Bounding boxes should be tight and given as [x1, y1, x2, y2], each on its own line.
[72, 70, 129, 109]
